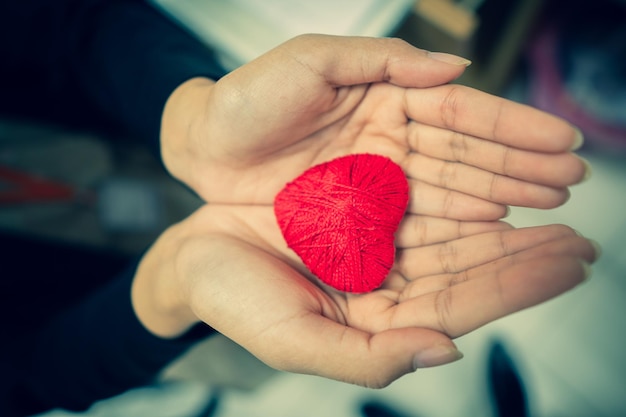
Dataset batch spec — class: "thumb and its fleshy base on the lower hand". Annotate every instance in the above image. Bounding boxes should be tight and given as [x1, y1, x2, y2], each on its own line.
[189, 234, 460, 388]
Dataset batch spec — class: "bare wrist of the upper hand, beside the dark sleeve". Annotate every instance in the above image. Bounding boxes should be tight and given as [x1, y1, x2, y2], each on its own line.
[160, 77, 215, 195]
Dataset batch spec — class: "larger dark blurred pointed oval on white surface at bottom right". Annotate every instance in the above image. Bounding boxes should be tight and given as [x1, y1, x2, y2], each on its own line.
[487, 342, 529, 417]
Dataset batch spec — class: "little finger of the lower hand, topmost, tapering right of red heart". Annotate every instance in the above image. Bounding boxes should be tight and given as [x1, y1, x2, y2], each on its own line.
[396, 214, 512, 249]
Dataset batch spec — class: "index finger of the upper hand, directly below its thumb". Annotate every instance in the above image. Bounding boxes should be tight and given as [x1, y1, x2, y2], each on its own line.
[405, 85, 582, 152]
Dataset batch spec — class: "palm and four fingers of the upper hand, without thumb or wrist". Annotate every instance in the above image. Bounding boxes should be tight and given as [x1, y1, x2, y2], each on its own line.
[183, 37, 584, 219]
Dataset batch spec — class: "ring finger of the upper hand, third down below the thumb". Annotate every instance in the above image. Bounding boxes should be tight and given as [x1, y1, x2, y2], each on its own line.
[405, 154, 569, 209]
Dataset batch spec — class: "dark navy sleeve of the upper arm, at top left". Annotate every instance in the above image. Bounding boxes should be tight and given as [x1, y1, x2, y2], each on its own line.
[0, 0, 224, 149]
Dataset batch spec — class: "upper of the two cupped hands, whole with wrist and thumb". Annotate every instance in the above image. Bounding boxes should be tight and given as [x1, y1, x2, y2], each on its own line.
[162, 35, 586, 220]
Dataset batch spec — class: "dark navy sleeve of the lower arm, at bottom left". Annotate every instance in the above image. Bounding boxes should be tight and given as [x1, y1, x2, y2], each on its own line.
[2, 265, 213, 416]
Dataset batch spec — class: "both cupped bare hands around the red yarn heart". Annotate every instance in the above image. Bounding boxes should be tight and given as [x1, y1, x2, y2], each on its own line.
[132, 35, 597, 387]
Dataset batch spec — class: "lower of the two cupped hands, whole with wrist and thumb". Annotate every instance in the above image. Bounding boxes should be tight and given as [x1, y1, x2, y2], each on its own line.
[133, 205, 596, 387]
